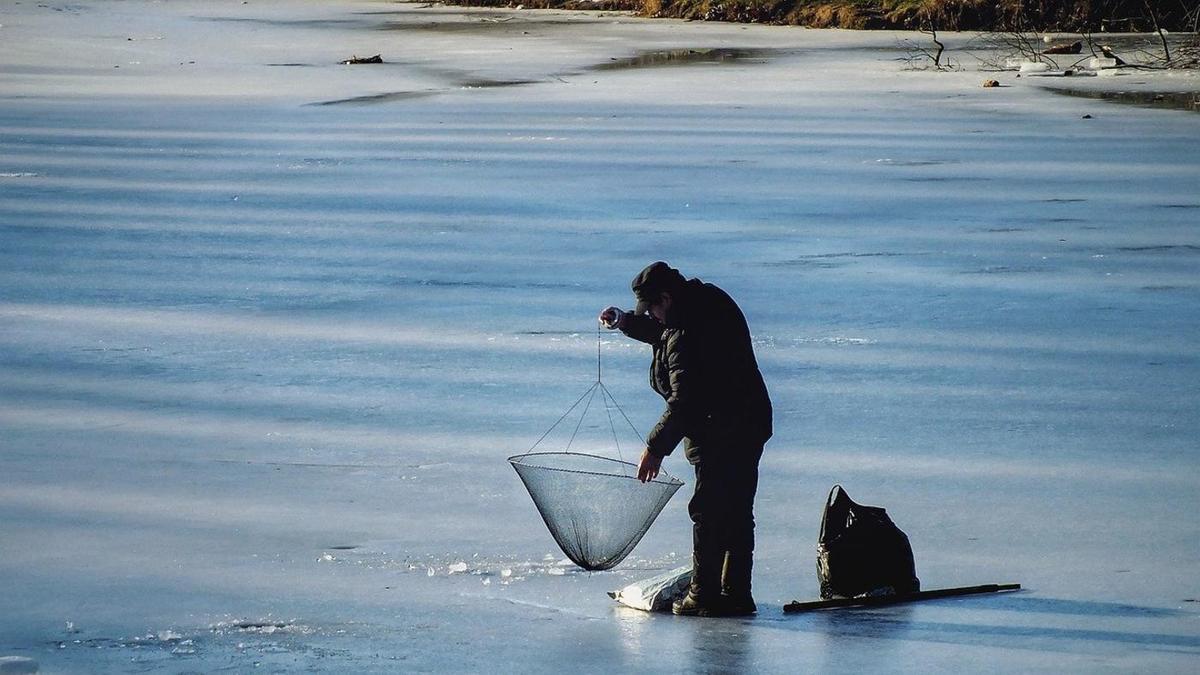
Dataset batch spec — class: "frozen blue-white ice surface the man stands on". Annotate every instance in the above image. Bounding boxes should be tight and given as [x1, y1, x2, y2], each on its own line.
[0, 0, 1200, 673]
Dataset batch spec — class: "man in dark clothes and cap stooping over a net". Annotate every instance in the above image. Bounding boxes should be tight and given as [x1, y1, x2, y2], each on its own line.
[600, 262, 772, 616]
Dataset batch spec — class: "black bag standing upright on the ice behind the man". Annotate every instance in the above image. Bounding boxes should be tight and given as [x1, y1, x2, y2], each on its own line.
[817, 485, 920, 599]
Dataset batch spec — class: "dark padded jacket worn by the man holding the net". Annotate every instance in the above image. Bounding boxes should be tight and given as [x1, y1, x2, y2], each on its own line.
[623, 279, 772, 464]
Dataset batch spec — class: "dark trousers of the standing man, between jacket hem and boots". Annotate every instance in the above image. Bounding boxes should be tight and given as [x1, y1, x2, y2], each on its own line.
[688, 444, 762, 556]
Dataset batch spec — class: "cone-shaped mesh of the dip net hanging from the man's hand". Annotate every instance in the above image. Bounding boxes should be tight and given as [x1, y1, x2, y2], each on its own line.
[509, 453, 683, 571]
